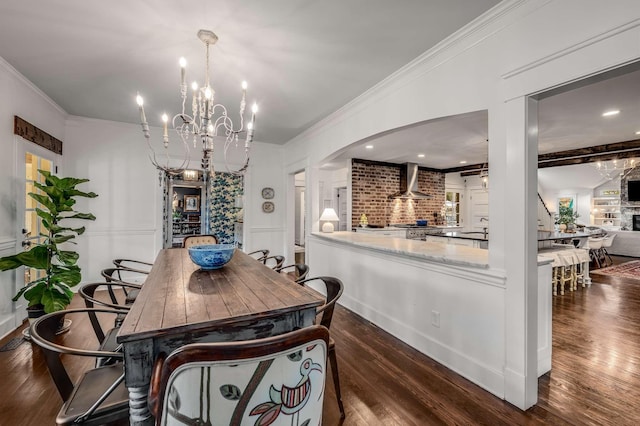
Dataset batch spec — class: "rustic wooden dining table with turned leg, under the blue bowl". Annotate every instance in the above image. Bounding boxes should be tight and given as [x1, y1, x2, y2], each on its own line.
[117, 248, 324, 425]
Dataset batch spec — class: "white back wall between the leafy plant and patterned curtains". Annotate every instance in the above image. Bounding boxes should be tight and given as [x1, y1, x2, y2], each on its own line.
[63, 117, 162, 282]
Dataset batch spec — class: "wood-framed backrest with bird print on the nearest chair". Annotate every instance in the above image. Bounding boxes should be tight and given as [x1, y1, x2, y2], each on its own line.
[149, 325, 329, 426]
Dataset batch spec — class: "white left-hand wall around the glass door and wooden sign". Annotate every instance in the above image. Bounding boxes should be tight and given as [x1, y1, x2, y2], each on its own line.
[0, 58, 67, 337]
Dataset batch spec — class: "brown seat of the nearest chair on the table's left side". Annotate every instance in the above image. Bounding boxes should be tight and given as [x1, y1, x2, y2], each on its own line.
[56, 363, 129, 425]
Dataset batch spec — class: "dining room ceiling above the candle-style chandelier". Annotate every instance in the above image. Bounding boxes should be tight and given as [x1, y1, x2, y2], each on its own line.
[0, 0, 499, 144]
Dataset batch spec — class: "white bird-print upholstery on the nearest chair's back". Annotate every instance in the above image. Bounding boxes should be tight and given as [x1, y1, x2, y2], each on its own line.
[160, 340, 327, 426]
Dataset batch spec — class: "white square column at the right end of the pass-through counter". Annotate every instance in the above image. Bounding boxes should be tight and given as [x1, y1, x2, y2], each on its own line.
[502, 97, 538, 410]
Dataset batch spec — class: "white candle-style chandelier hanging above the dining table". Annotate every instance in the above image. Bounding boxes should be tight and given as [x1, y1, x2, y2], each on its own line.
[136, 30, 258, 179]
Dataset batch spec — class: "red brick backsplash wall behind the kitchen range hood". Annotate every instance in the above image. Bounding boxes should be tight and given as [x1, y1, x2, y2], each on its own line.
[351, 159, 444, 226]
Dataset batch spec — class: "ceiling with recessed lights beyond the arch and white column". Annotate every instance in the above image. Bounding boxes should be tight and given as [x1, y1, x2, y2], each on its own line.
[327, 65, 640, 171]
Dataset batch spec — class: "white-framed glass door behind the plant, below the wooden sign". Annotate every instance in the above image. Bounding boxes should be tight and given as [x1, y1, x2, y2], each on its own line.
[14, 141, 60, 327]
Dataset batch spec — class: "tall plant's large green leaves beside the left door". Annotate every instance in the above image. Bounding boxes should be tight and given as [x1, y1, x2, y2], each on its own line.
[0, 170, 97, 317]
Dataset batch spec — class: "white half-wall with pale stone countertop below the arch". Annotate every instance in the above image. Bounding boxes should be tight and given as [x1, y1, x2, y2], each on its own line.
[306, 232, 552, 404]
